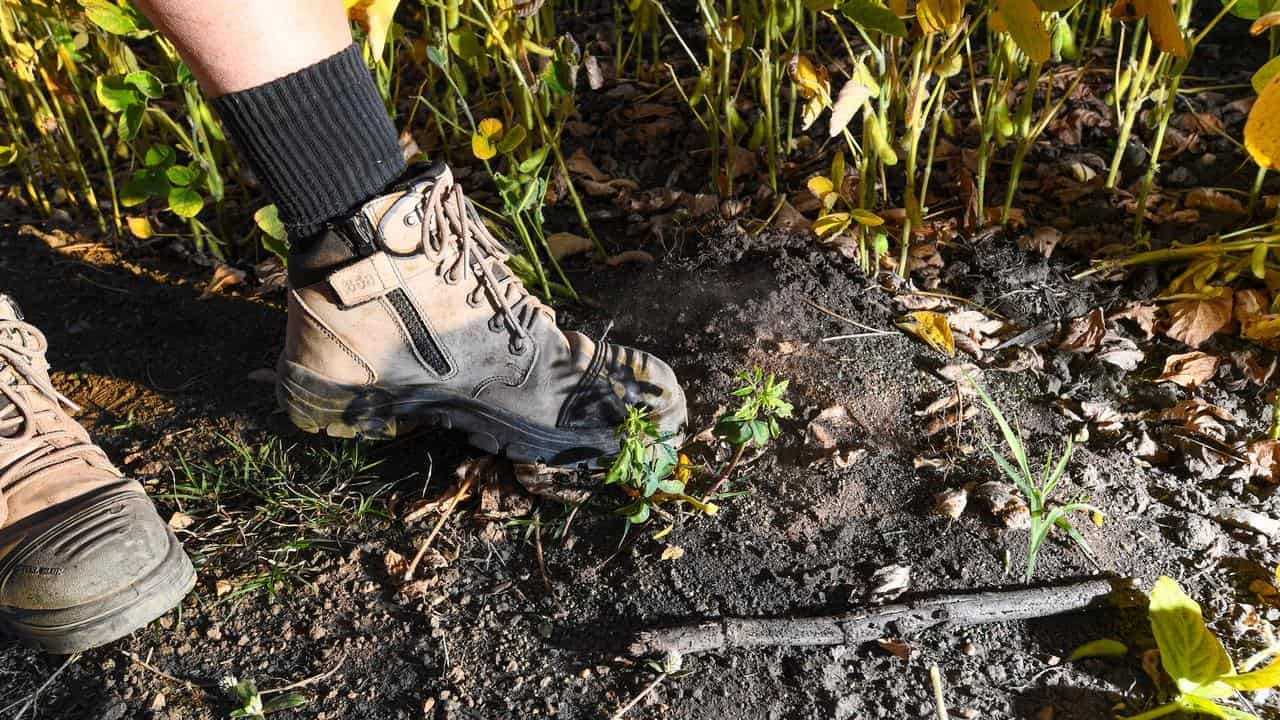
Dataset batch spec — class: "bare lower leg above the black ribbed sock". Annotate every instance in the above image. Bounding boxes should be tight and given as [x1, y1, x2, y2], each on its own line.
[137, 0, 351, 97]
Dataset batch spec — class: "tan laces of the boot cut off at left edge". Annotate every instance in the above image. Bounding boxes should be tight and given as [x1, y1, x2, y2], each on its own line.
[0, 320, 102, 524]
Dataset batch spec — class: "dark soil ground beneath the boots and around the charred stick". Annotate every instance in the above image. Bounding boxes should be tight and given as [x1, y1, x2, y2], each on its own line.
[0, 12, 1280, 720]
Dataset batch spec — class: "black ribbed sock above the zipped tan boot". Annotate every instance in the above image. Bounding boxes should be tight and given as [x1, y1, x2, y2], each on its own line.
[214, 44, 404, 243]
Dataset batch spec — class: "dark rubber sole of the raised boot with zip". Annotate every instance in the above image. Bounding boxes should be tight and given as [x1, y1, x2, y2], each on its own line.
[275, 359, 684, 466]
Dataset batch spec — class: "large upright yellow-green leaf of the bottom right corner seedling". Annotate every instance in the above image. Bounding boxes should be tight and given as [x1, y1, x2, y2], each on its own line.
[1148, 577, 1234, 694]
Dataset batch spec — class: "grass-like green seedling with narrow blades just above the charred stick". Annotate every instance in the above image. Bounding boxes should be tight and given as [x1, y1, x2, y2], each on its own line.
[965, 375, 1102, 582]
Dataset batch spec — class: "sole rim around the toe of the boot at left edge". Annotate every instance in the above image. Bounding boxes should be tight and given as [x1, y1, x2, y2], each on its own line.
[0, 525, 196, 655]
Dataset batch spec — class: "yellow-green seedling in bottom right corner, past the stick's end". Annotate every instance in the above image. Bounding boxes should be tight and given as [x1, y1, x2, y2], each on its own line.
[1129, 577, 1280, 720]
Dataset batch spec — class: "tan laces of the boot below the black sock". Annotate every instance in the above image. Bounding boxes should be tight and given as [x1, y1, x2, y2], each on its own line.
[406, 170, 554, 355]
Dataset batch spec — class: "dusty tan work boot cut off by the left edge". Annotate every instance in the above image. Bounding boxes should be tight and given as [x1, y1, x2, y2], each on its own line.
[0, 295, 196, 653]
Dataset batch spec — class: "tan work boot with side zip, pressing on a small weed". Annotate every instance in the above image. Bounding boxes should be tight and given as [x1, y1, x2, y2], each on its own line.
[276, 164, 685, 465]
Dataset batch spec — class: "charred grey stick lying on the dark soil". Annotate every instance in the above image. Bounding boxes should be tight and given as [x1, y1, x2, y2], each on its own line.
[628, 571, 1112, 656]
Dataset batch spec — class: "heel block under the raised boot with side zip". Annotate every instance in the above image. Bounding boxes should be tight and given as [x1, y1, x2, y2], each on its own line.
[275, 359, 399, 439]
